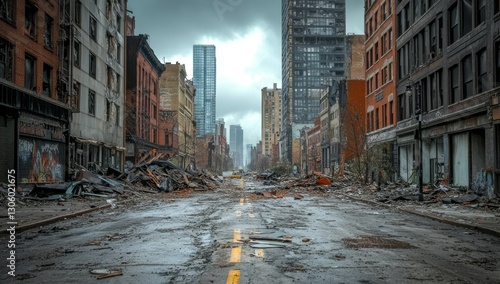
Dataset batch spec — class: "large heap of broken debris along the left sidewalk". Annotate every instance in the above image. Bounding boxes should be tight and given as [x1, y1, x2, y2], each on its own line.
[21, 155, 220, 200]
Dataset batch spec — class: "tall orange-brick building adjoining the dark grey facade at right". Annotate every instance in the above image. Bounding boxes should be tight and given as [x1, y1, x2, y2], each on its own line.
[365, 0, 397, 180]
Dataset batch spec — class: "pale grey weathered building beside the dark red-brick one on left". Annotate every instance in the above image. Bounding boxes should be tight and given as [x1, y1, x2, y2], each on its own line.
[66, 0, 126, 170]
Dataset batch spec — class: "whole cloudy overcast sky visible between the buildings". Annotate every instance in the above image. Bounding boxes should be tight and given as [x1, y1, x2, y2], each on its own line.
[128, 0, 364, 151]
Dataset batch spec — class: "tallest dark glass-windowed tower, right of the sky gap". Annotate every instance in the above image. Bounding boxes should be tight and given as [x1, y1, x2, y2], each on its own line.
[280, 0, 346, 164]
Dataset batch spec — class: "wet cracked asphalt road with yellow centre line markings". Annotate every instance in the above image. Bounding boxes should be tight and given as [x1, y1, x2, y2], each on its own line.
[0, 181, 500, 284]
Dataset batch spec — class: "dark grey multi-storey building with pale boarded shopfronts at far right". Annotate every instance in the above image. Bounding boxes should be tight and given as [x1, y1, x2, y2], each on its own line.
[395, 0, 500, 196]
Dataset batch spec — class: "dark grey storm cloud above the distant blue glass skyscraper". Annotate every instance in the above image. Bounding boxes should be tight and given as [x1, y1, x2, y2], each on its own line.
[128, 0, 281, 54]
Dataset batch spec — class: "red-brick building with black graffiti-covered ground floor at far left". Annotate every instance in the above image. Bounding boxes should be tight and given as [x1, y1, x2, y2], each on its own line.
[0, 0, 71, 186]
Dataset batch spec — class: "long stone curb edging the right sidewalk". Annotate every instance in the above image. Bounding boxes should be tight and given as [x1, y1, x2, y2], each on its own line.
[338, 193, 500, 237]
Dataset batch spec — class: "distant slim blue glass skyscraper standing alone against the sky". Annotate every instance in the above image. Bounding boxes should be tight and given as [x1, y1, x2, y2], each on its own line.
[193, 45, 216, 137]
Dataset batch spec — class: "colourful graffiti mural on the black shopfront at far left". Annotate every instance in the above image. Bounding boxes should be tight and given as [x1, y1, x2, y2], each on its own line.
[19, 137, 65, 183]
